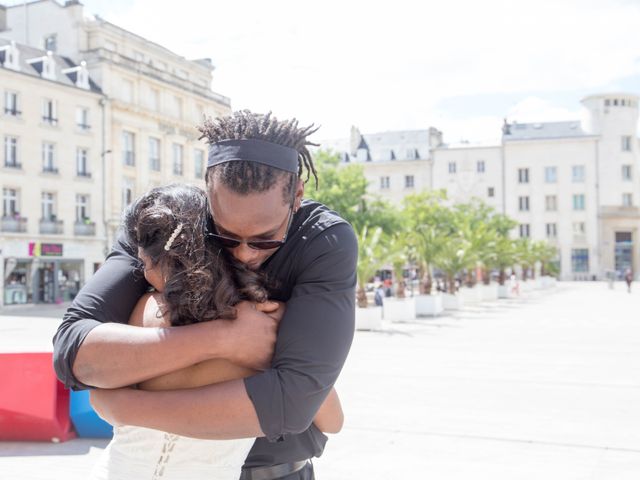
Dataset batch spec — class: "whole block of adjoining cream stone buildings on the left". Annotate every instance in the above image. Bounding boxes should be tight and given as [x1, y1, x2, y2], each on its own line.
[0, 0, 231, 303]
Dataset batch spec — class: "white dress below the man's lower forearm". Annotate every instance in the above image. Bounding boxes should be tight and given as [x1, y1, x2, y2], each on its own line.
[89, 426, 254, 480]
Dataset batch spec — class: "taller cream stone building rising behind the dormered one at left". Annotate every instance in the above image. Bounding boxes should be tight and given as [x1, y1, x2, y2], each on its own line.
[0, 0, 231, 246]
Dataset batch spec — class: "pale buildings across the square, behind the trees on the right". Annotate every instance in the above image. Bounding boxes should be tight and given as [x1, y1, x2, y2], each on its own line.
[329, 93, 640, 280]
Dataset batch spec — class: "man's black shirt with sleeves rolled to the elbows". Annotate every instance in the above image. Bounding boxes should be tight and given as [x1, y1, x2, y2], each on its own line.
[53, 200, 358, 466]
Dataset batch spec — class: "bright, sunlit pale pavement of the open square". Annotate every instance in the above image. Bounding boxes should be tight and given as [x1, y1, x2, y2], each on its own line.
[0, 282, 640, 480]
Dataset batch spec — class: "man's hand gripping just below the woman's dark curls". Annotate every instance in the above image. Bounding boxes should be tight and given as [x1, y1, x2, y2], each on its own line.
[216, 302, 282, 370]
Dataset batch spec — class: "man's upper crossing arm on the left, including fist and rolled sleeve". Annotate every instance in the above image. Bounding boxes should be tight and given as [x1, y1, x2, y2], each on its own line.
[53, 238, 276, 388]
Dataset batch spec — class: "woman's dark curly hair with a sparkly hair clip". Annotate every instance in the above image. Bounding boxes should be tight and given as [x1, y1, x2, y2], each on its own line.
[123, 184, 266, 325]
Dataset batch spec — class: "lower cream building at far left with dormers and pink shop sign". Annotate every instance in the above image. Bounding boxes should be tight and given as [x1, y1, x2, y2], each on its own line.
[0, 39, 105, 305]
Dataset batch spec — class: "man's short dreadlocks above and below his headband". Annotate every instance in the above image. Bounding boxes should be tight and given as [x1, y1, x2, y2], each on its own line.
[197, 110, 319, 202]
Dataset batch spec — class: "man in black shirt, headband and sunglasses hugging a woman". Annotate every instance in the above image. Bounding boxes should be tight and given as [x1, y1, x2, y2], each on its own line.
[54, 111, 357, 480]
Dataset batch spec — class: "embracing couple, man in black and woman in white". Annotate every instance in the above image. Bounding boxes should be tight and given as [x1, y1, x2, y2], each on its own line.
[54, 111, 357, 480]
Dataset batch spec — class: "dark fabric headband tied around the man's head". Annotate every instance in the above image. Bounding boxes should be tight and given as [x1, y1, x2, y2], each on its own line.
[207, 139, 298, 173]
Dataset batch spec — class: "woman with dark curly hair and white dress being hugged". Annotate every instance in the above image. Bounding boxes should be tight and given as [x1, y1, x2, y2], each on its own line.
[90, 184, 343, 480]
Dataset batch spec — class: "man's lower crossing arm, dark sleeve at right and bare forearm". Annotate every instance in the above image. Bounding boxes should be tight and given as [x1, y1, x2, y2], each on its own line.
[92, 224, 357, 440]
